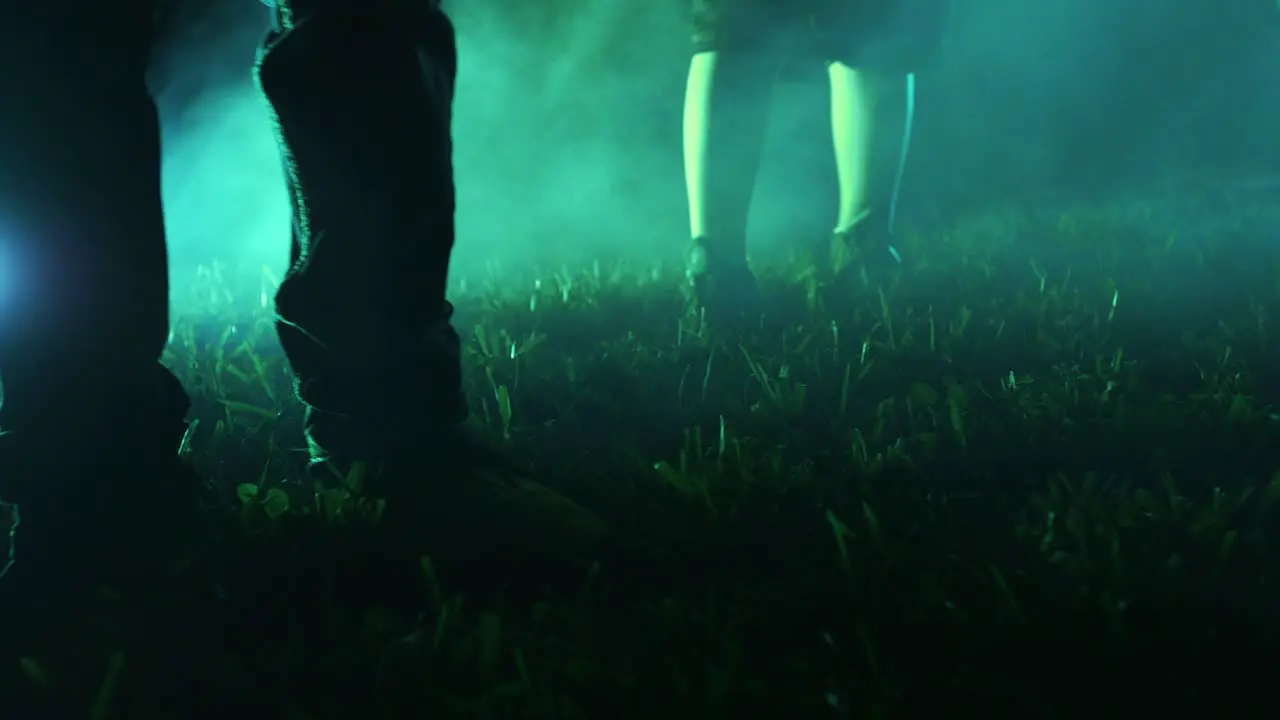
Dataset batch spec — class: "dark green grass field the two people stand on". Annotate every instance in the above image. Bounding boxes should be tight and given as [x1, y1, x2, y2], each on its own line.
[2, 192, 1280, 720]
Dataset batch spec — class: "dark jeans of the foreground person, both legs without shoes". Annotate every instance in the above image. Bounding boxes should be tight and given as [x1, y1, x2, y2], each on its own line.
[0, 0, 465, 486]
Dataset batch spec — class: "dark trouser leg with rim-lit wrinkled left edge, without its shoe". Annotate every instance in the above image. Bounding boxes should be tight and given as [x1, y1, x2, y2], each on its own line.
[259, 4, 466, 461]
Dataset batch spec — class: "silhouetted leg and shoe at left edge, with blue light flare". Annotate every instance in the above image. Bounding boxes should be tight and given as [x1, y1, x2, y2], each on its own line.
[0, 0, 212, 716]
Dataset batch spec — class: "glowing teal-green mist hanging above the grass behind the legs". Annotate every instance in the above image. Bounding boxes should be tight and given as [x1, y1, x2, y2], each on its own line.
[155, 0, 1280, 313]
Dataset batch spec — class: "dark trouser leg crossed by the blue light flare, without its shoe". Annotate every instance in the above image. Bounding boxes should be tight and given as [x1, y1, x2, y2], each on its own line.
[0, 0, 186, 456]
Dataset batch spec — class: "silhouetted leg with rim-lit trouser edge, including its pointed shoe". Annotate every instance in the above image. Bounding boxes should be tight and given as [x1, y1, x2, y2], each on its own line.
[259, 3, 608, 568]
